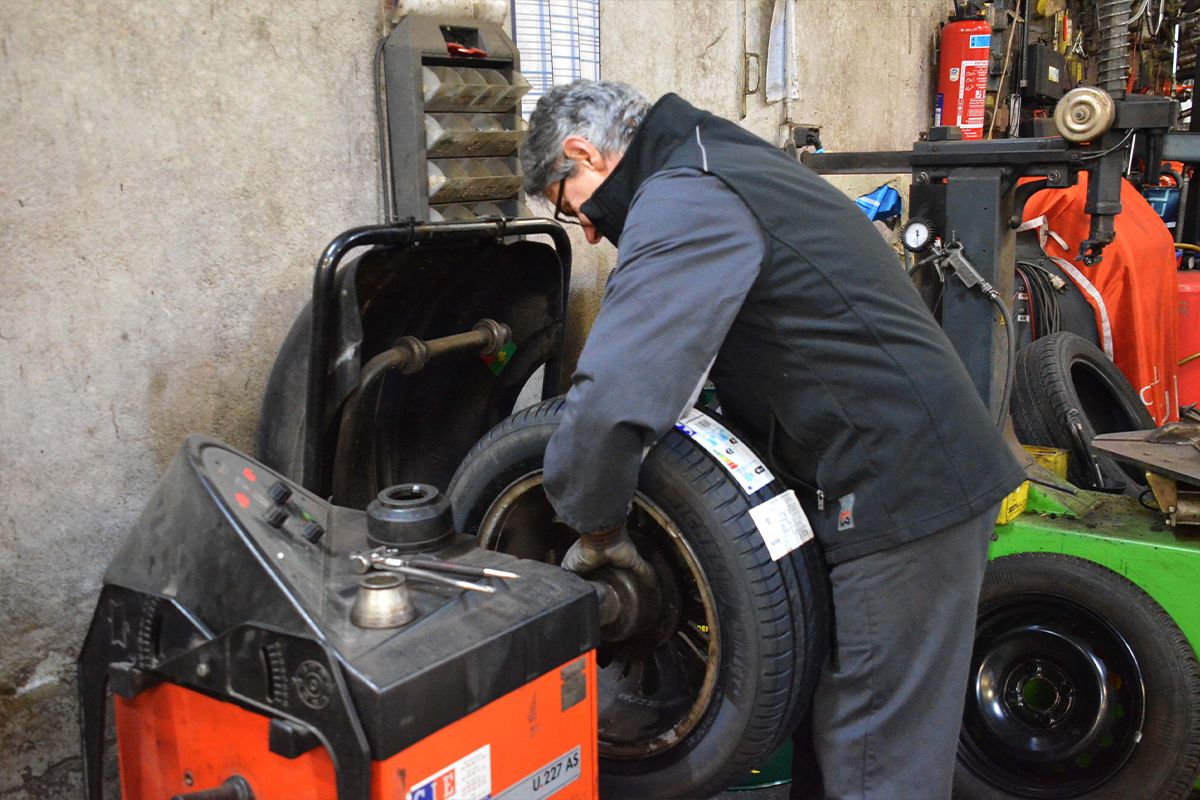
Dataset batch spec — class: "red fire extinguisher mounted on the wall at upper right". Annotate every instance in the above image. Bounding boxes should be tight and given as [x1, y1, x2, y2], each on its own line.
[934, 0, 991, 139]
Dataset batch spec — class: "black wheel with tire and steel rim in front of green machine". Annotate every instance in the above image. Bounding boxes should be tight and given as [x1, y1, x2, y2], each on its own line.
[954, 553, 1200, 800]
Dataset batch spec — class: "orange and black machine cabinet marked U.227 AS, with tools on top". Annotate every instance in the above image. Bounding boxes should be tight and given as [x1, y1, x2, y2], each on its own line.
[78, 437, 600, 800]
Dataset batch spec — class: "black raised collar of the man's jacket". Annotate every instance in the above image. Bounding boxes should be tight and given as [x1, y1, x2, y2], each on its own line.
[580, 94, 708, 245]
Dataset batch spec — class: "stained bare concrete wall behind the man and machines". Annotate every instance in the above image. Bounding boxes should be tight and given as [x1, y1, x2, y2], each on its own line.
[0, 0, 948, 800]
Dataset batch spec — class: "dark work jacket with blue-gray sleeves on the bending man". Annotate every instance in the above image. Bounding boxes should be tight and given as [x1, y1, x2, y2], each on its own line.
[546, 95, 1022, 563]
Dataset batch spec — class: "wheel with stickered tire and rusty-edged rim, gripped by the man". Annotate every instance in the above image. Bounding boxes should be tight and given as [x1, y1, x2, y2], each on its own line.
[449, 399, 829, 799]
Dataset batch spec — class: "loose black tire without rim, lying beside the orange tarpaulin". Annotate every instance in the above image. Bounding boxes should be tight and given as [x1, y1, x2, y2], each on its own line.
[1013, 332, 1154, 494]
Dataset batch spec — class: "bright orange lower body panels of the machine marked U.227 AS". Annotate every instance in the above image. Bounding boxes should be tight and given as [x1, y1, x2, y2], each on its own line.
[115, 651, 599, 800]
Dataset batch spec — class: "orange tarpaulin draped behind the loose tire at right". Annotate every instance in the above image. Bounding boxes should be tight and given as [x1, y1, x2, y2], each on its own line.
[1024, 173, 1178, 425]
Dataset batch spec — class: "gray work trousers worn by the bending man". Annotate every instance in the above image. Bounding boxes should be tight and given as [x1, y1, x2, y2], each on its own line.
[792, 509, 996, 800]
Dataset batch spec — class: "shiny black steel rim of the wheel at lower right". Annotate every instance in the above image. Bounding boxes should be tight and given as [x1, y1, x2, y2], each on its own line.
[959, 594, 1146, 798]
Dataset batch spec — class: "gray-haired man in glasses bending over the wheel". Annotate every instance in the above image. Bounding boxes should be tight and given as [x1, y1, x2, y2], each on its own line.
[521, 80, 1022, 800]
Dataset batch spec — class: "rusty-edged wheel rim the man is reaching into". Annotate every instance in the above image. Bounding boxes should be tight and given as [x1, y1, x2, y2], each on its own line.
[479, 471, 720, 760]
